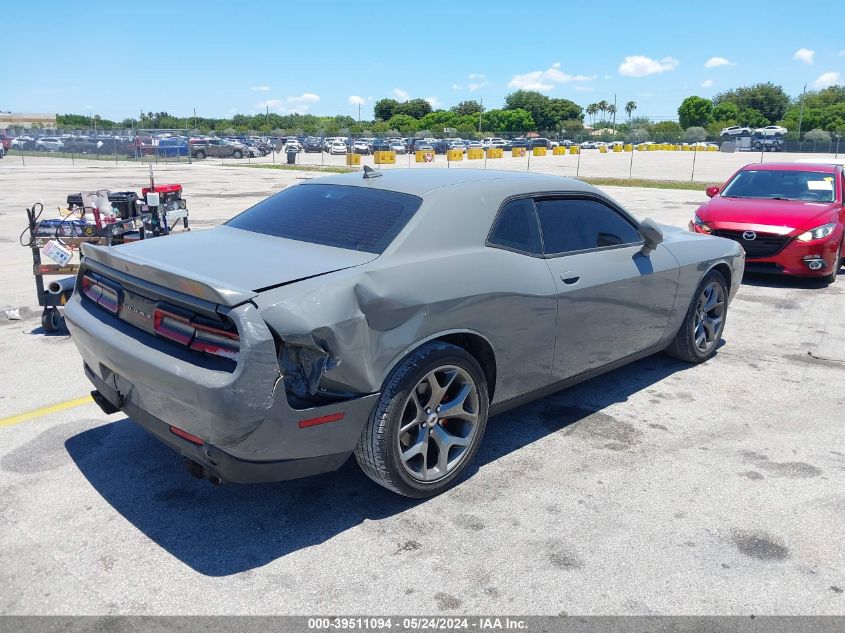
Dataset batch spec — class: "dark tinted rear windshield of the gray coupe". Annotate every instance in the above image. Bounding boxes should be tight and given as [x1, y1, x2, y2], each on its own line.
[226, 184, 422, 254]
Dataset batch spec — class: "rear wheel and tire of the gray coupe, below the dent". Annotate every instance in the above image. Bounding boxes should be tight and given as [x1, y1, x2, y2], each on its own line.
[355, 342, 489, 498]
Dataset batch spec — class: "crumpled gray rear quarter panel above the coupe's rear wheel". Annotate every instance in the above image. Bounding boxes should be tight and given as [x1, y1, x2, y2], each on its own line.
[255, 188, 557, 401]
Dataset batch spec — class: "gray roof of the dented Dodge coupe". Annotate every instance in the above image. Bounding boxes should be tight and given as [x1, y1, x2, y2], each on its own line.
[302, 169, 598, 196]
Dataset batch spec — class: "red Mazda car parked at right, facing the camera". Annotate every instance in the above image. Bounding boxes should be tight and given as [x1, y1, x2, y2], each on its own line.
[689, 163, 845, 283]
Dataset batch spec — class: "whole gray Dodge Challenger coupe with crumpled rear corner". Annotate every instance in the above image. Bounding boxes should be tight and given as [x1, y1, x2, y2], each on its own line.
[65, 169, 745, 497]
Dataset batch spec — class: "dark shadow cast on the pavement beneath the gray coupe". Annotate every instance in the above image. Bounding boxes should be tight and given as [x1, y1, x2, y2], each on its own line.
[65, 354, 690, 576]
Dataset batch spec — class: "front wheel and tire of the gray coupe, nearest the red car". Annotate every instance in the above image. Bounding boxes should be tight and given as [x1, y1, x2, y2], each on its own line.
[666, 270, 728, 363]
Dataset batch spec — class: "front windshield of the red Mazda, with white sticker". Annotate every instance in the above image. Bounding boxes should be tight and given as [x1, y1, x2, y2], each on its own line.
[722, 169, 836, 202]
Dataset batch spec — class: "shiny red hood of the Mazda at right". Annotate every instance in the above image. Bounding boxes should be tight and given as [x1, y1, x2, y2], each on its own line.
[697, 196, 837, 233]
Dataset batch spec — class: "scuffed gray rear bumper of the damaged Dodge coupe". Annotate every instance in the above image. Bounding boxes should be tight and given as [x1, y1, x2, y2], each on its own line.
[65, 294, 379, 482]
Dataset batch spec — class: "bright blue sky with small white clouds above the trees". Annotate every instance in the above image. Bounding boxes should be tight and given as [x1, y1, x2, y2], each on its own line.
[0, 0, 845, 120]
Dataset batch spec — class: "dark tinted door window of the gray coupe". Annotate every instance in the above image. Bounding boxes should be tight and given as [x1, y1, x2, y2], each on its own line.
[536, 198, 643, 255]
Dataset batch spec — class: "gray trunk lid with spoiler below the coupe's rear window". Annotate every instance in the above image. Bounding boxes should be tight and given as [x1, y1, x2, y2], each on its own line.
[84, 226, 378, 305]
